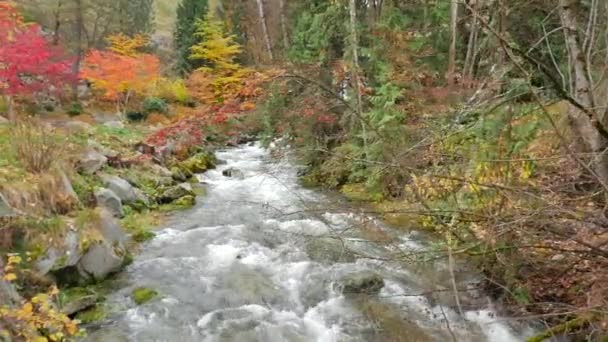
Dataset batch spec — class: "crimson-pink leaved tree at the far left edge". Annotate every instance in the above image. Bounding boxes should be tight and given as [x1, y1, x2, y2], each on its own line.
[0, 3, 73, 121]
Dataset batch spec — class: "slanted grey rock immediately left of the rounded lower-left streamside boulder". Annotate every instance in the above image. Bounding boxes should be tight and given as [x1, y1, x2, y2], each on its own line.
[36, 231, 82, 275]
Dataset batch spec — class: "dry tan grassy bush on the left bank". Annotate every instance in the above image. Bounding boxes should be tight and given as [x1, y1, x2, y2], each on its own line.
[11, 120, 65, 173]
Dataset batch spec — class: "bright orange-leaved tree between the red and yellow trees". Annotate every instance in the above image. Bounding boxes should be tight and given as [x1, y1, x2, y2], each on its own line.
[81, 35, 160, 112]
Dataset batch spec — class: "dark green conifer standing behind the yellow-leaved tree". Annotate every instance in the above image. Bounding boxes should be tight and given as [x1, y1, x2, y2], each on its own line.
[174, 0, 208, 74]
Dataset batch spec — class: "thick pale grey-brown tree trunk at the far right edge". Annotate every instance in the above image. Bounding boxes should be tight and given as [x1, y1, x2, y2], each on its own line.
[559, 0, 608, 187]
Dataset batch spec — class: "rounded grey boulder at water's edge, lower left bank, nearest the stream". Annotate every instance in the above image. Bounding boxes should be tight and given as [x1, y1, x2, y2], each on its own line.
[78, 241, 125, 281]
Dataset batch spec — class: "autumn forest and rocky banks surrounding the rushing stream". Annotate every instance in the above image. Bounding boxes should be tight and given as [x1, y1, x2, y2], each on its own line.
[0, 0, 608, 342]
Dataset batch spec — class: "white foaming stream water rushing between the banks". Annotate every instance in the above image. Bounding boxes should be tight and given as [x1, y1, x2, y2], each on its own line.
[90, 146, 522, 342]
